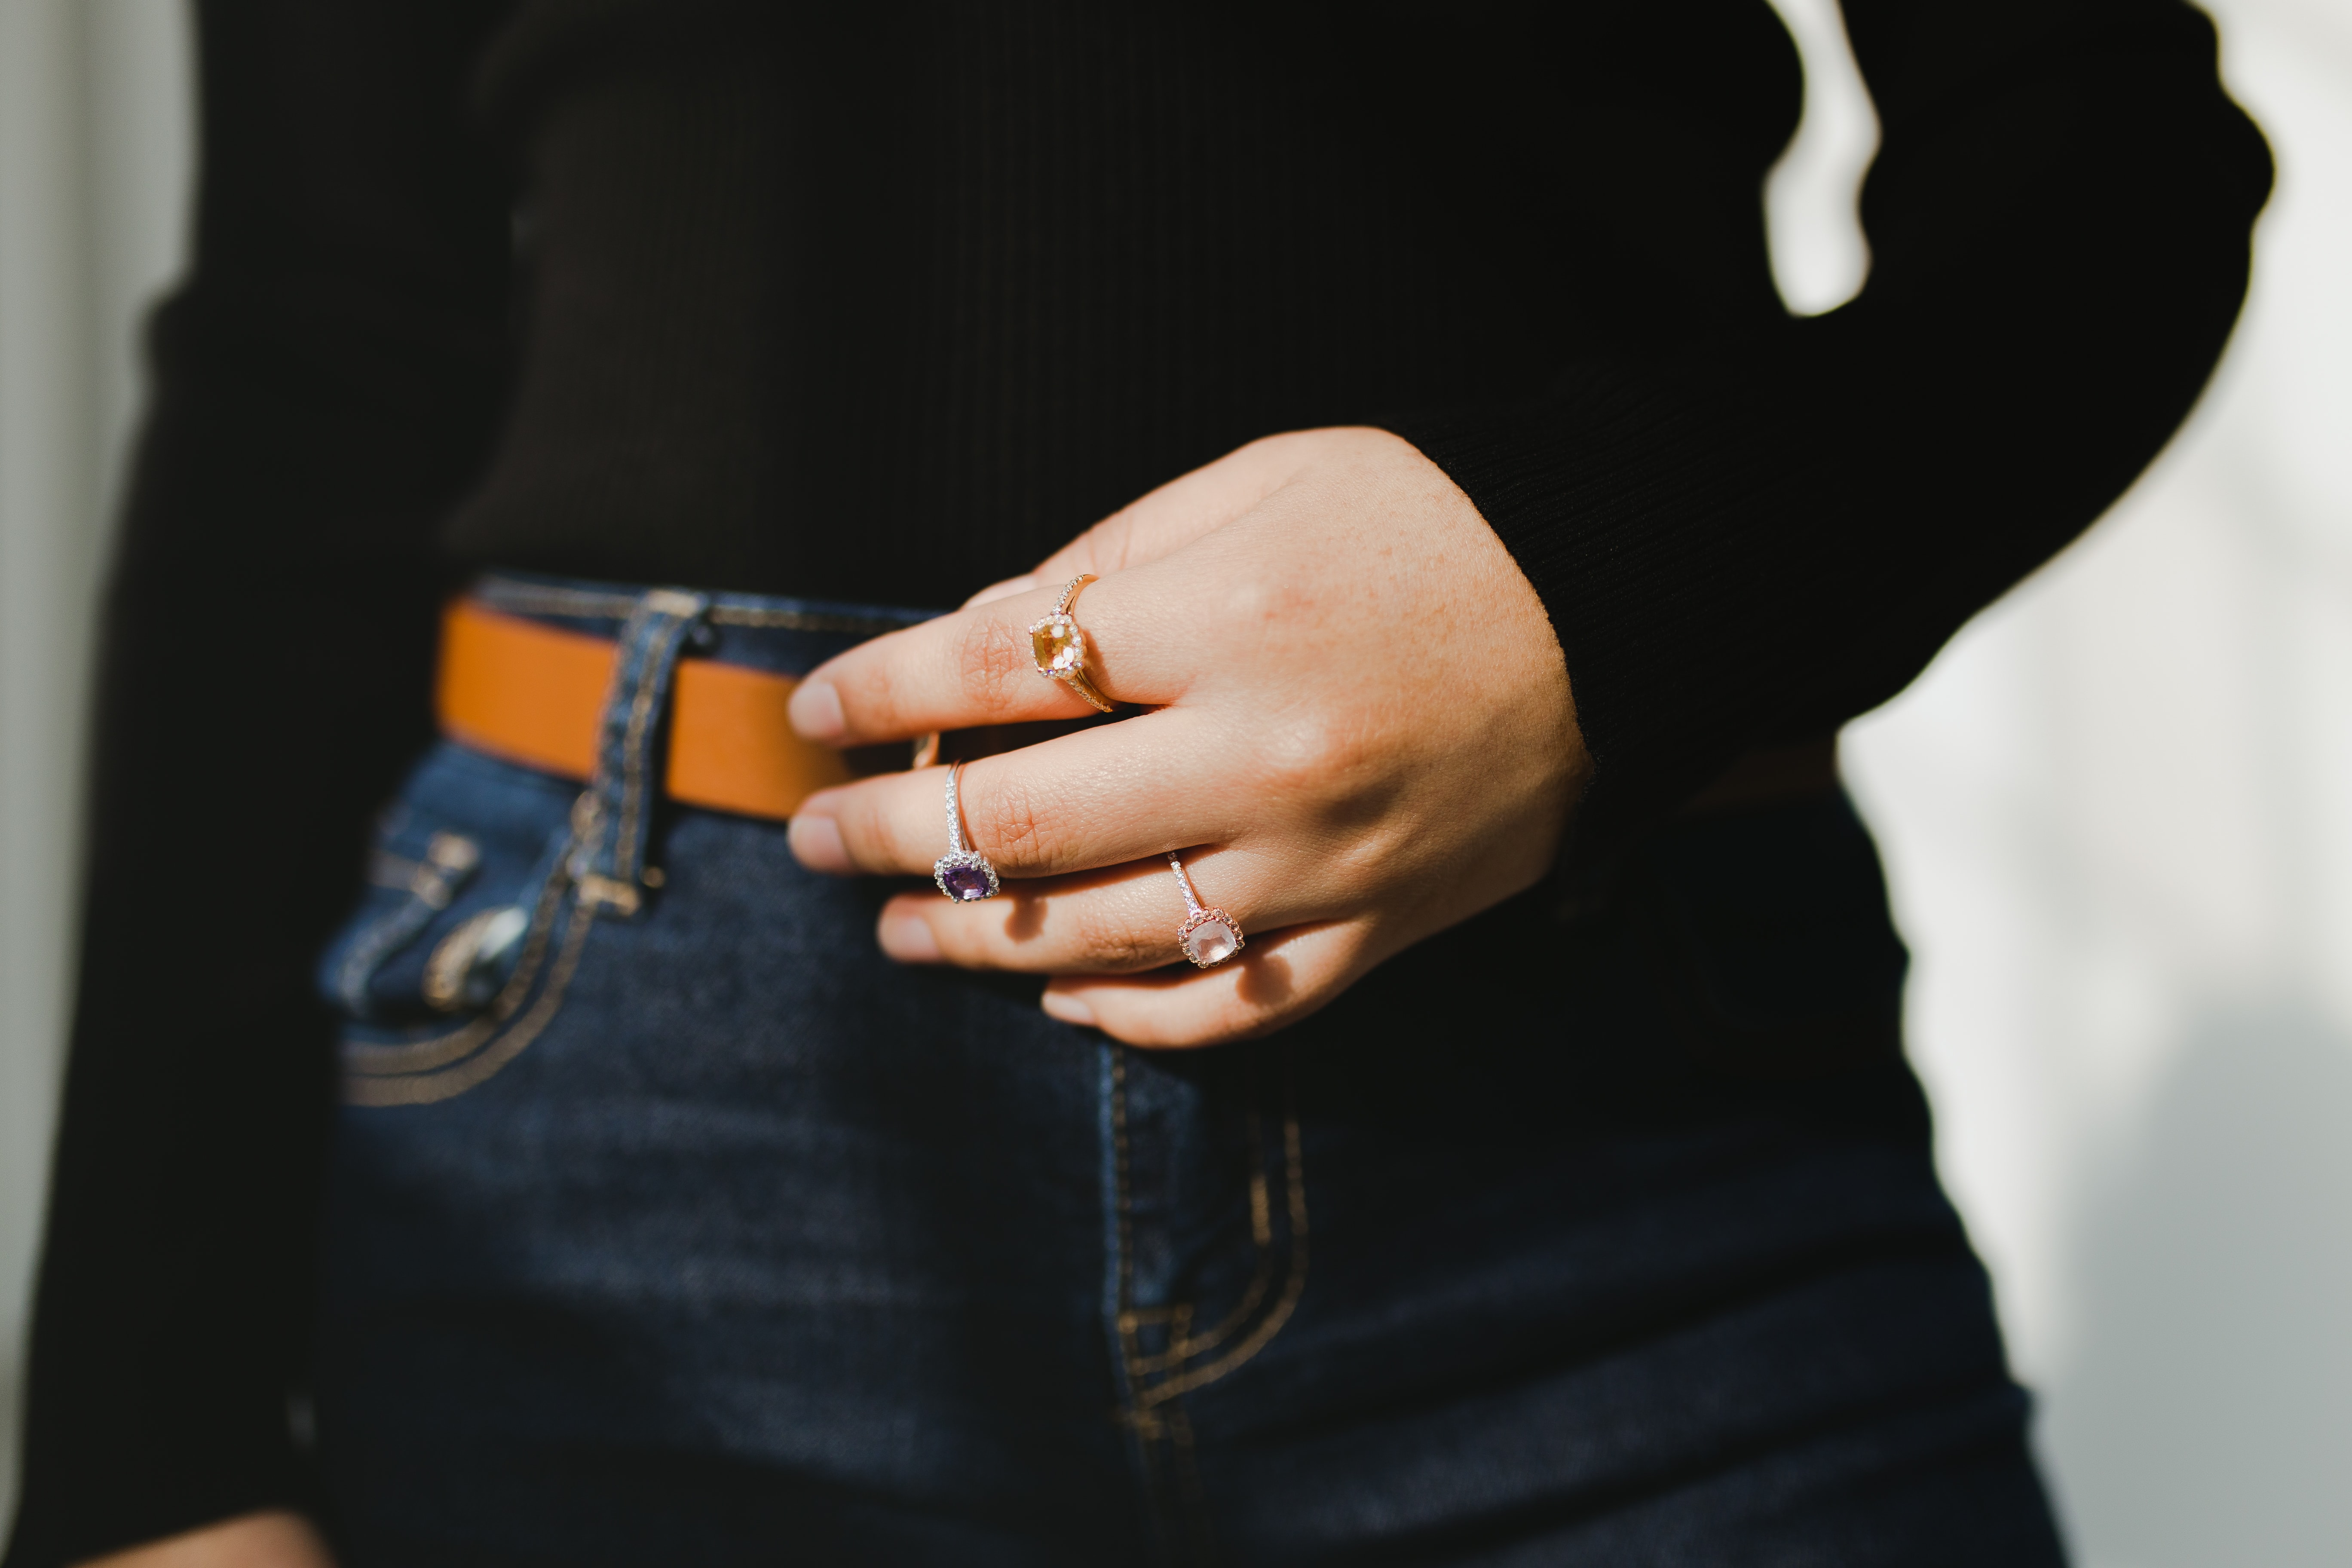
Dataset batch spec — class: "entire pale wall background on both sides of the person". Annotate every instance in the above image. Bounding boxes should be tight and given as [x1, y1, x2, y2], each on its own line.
[0, 0, 2352, 1568]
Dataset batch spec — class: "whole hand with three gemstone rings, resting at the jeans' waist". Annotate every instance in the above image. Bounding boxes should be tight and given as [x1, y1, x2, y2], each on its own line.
[790, 430, 1590, 1046]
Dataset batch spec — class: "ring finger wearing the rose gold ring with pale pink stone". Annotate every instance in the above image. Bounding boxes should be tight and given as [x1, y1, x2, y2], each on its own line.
[875, 848, 1334, 976]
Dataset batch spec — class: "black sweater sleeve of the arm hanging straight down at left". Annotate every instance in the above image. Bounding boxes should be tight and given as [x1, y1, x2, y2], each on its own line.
[7, 0, 508, 1568]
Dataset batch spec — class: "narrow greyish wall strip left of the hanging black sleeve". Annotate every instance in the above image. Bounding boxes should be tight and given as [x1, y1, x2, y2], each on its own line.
[0, 0, 190, 1519]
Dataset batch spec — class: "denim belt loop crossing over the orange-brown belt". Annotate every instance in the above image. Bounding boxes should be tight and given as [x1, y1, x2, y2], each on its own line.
[567, 588, 710, 919]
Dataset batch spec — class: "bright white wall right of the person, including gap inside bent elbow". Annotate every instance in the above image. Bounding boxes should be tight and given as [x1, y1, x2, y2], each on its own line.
[1773, 0, 2352, 1568]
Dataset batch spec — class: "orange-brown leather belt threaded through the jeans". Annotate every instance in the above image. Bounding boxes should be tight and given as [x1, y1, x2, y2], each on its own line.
[433, 600, 851, 821]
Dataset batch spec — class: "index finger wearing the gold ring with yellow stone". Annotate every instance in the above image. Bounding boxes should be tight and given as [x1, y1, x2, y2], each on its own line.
[790, 562, 1188, 745]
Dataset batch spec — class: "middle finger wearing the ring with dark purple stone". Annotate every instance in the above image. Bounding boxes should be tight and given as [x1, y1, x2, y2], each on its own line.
[790, 710, 1249, 877]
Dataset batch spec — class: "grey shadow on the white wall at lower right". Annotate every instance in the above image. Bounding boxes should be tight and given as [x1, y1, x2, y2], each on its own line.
[2044, 1013, 2352, 1568]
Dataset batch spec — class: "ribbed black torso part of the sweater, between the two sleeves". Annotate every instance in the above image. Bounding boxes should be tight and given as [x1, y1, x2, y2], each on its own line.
[449, 0, 1797, 604]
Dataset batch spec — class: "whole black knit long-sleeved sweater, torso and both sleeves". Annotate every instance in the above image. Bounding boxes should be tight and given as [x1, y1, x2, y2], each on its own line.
[7, 0, 2269, 1568]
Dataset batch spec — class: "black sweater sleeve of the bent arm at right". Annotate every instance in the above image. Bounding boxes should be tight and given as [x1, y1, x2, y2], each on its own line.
[1385, 0, 2269, 879]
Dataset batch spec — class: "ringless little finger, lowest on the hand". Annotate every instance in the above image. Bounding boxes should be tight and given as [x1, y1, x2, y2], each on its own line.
[1042, 917, 1383, 1046]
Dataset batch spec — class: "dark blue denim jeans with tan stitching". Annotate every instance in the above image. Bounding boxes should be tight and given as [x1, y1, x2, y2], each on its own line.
[315, 578, 2058, 1568]
